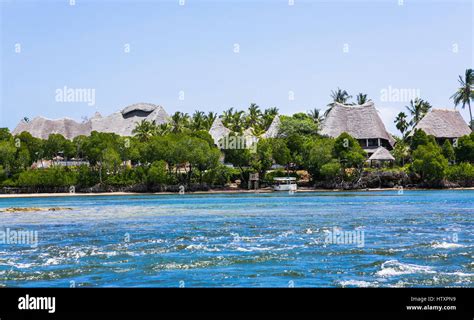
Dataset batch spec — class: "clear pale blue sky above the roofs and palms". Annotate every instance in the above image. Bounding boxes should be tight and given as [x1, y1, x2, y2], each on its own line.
[0, 0, 474, 133]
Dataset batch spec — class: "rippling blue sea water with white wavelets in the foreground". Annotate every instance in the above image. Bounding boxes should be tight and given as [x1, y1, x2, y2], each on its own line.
[0, 190, 474, 287]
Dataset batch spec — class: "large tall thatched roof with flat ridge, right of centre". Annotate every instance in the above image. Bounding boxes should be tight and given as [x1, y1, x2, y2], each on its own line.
[321, 102, 395, 145]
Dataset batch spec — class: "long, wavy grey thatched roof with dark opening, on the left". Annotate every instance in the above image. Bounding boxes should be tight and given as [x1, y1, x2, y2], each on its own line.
[13, 103, 168, 139]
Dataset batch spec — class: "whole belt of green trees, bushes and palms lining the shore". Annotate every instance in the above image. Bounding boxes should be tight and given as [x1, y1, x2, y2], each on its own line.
[0, 71, 474, 190]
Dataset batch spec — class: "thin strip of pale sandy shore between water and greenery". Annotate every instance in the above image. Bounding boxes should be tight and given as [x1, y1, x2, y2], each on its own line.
[0, 187, 474, 199]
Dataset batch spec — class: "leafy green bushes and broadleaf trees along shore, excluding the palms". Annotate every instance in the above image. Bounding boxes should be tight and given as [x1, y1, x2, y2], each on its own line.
[0, 114, 474, 189]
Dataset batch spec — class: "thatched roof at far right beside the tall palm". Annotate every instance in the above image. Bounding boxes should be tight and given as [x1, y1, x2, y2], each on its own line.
[412, 109, 471, 138]
